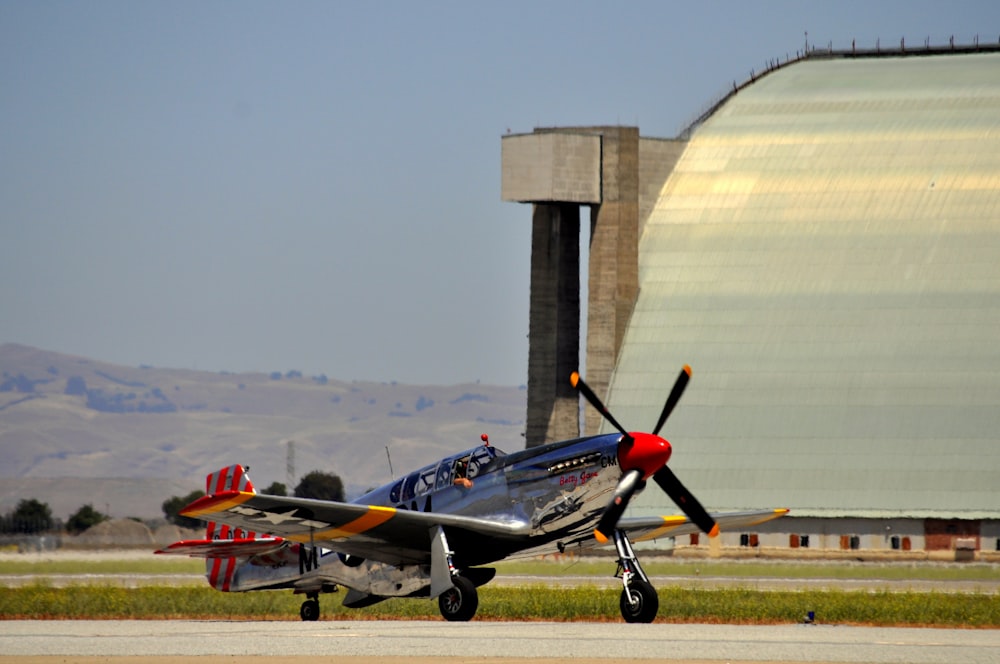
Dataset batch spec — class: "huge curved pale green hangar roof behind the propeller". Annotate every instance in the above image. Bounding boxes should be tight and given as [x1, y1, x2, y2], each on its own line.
[608, 54, 1000, 519]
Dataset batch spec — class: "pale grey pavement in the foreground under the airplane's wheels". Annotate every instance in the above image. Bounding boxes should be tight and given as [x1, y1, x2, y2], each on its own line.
[0, 620, 1000, 664]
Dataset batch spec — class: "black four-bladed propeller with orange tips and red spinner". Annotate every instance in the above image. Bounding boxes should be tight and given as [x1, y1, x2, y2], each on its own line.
[570, 365, 719, 543]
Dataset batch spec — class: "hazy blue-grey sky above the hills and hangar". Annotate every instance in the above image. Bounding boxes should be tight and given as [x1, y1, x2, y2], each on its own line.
[0, 0, 1000, 385]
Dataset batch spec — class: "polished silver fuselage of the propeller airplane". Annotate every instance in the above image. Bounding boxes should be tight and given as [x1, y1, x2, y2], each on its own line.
[230, 433, 621, 597]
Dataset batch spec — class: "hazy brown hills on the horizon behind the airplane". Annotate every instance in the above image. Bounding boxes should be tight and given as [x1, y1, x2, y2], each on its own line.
[0, 344, 527, 518]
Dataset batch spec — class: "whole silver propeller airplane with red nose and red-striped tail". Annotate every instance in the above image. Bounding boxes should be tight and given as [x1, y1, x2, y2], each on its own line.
[157, 366, 788, 623]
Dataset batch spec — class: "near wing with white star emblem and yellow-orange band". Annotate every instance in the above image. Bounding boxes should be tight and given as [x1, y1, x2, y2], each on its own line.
[181, 491, 530, 565]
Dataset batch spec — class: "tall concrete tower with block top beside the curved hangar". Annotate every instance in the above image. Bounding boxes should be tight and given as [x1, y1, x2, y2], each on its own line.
[501, 127, 656, 447]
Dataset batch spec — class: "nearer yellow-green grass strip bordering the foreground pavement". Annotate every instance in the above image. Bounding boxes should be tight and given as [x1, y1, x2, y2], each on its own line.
[0, 584, 1000, 629]
